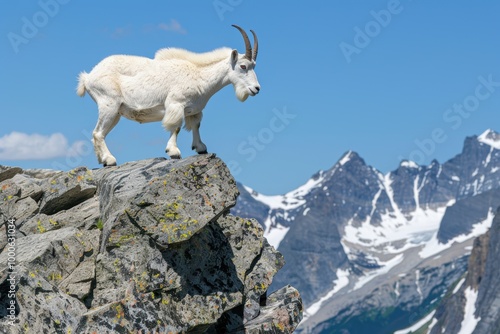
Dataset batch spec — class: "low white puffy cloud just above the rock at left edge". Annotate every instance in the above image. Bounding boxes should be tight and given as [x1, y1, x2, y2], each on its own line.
[0, 131, 88, 160]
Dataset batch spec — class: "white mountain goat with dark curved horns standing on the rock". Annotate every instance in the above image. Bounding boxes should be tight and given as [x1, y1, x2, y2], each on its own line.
[77, 25, 260, 166]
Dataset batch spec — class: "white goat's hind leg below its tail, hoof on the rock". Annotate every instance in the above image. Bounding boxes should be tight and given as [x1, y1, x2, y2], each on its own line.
[92, 104, 120, 167]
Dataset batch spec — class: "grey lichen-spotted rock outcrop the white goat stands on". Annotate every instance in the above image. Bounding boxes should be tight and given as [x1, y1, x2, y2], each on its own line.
[0, 155, 302, 334]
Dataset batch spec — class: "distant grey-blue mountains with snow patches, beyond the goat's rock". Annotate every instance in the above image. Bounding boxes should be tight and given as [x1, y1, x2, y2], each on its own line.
[232, 130, 500, 333]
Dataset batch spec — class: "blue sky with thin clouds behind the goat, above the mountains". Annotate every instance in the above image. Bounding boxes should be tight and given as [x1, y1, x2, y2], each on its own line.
[0, 0, 500, 194]
